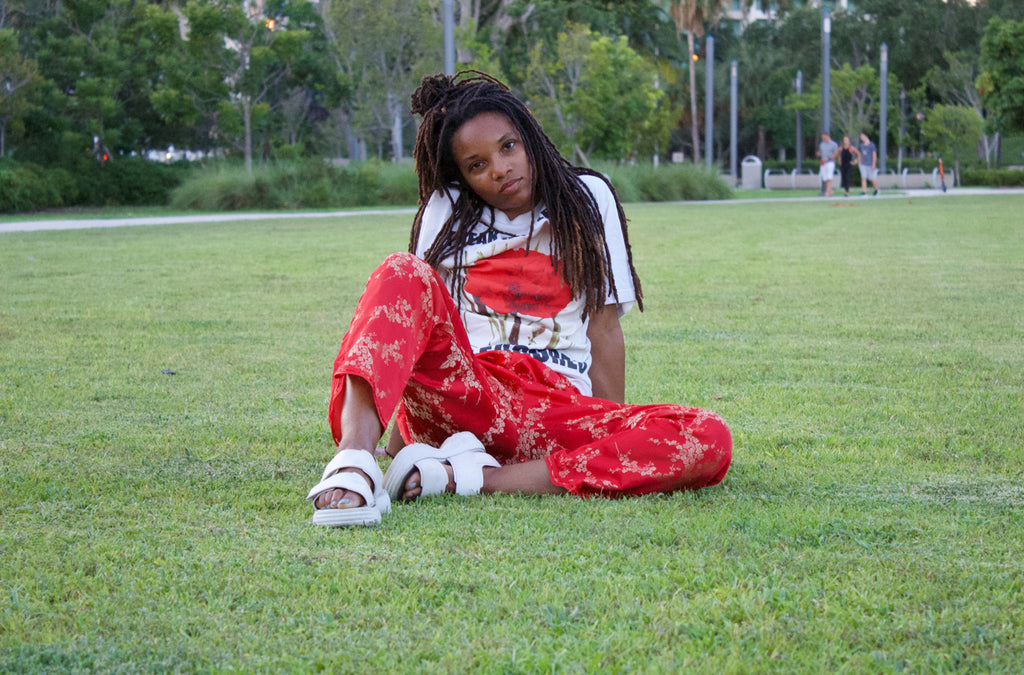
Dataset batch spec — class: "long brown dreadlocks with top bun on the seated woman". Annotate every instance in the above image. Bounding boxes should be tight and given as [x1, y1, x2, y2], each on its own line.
[410, 71, 643, 314]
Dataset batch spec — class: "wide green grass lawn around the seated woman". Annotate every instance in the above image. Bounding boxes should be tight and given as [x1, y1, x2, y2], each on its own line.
[0, 196, 1024, 673]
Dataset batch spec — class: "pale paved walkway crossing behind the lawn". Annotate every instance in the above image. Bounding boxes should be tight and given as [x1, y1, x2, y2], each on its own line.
[0, 187, 1024, 234]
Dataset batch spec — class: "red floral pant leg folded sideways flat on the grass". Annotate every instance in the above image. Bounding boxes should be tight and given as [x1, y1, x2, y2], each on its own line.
[468, 352, 732, 497]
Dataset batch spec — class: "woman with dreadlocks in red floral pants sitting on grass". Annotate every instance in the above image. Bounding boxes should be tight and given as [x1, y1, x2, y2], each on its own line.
[308, 73, 732, 526]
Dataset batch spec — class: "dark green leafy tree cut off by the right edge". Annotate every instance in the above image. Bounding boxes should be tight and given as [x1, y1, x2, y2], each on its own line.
[977, 16, 1024, 132]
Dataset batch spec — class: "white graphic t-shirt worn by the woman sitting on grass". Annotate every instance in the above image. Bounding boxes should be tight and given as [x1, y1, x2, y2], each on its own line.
[416, 176, 636, 395]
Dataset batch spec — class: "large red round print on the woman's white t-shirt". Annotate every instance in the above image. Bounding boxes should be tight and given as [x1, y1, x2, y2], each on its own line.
[465, 249, 572, 319]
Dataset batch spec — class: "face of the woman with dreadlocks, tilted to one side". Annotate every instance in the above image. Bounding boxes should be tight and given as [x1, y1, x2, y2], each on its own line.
[452, 113, 536, 218]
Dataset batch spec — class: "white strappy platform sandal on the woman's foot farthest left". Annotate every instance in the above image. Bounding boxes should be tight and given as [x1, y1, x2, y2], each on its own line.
[306, 450, 391, 528]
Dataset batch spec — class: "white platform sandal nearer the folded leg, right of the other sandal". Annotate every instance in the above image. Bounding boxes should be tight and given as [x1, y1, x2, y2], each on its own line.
[384, 431, 501, 500]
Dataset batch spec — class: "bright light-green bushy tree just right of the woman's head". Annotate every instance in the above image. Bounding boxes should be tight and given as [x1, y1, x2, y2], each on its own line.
[523, 24, 675, 166]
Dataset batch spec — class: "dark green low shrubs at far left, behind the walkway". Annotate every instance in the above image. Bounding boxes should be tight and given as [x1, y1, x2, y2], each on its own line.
[0, 157, 188, 213]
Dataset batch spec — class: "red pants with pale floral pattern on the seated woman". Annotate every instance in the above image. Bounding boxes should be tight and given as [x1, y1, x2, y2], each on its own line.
[328, 253, 732, 497]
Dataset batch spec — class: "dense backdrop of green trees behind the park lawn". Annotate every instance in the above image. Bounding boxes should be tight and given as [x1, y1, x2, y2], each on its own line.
[6, 0, 1024, 184]
